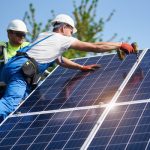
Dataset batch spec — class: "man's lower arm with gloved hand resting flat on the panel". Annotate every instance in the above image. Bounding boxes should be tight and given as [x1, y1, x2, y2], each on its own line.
[56, 56, 100, 71]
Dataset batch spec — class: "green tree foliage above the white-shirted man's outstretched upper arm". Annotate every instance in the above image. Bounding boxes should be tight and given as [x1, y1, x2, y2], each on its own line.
[73, 0, 104, 42]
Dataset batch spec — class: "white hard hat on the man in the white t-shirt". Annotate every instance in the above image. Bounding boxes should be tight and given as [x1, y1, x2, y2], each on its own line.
[51, 14, 77, 33]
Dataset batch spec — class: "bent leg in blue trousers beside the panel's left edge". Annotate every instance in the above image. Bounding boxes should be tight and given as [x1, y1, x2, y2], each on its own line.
[0, 74, 27, 118]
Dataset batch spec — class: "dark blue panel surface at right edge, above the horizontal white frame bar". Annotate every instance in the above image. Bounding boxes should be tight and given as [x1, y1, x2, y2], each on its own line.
[117, 50, 150, 102]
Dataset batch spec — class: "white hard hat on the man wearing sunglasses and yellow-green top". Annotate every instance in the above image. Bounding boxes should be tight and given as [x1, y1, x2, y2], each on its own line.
[7, 19, 28, 33]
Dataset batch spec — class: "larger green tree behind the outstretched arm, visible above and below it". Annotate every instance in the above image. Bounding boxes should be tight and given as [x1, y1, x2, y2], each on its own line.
[64, 0, 115, 58]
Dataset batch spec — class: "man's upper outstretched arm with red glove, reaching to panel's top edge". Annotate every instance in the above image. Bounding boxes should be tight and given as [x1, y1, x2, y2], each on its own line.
[70, 40, 134, 53]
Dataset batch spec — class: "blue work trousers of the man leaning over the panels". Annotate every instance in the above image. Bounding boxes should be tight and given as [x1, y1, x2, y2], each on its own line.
[0, 56, 29, 119]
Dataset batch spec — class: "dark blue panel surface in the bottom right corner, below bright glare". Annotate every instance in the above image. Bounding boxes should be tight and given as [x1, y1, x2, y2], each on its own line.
[88, 103, 150, 150]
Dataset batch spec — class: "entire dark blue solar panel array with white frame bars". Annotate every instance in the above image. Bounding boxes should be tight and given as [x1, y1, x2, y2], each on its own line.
[0, 50, 150, 150]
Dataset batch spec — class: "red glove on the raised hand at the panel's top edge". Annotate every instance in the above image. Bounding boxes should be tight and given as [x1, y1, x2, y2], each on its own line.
[120, 43, 136, 54]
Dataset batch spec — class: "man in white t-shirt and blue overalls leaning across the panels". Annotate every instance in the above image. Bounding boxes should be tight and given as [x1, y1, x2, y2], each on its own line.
[0, 14, 135, 118]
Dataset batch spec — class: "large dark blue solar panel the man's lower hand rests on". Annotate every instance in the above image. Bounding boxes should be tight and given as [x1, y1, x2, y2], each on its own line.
[14, 54, 136, 113]
